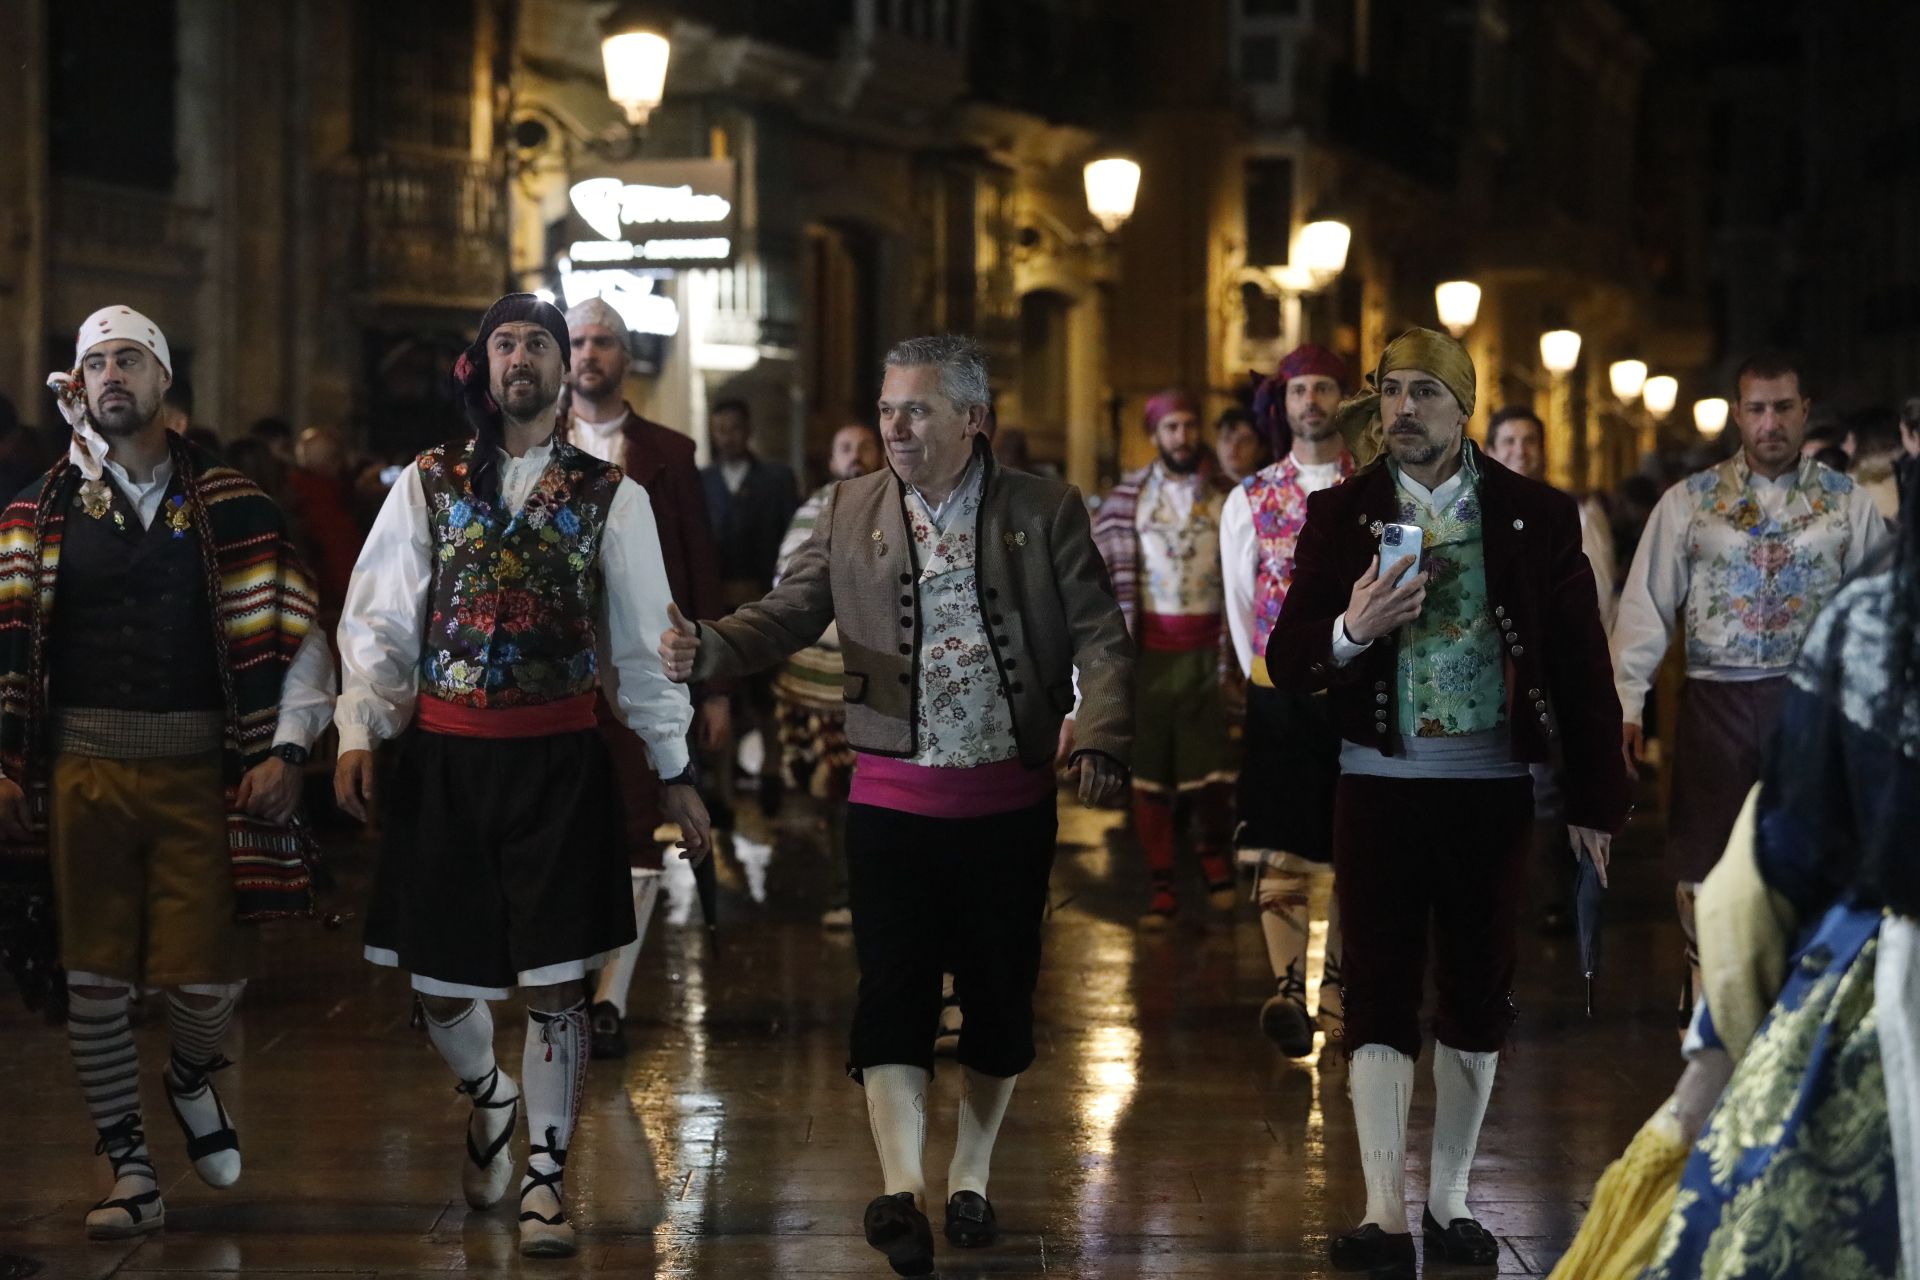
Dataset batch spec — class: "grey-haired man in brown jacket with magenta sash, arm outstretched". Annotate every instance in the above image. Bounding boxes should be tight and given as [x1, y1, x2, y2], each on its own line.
[660, 336, 1133, 1276]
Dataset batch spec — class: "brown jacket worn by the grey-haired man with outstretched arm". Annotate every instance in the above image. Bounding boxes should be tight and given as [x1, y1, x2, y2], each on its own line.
[693, 443, 1133, 768]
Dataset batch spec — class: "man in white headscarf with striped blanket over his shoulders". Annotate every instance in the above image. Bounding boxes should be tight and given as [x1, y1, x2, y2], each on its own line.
[0, 307, 332, 1240]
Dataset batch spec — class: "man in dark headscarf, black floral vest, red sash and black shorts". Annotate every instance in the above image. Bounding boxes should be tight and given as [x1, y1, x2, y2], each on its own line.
[334, 294, 708, 1257]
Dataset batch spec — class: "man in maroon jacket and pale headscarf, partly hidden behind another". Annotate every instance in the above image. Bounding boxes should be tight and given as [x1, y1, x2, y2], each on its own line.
[566, 297, 732, 1057]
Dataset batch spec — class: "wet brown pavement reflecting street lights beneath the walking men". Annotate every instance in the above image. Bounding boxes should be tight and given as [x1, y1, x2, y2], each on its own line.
[0, 790, 1678, 1278]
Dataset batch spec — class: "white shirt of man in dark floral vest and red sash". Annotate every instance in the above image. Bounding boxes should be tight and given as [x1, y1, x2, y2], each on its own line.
[334, 441, 693, 777]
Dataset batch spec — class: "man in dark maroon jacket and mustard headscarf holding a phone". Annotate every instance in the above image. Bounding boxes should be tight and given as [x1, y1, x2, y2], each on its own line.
[1267, 328, 1628, 1280]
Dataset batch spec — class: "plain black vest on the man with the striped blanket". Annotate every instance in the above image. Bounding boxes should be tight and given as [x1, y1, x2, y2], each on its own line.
[48, 474, 225, 712]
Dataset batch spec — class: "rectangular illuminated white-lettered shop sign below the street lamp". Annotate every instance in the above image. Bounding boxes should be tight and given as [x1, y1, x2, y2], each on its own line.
[555, 159, 737, 267]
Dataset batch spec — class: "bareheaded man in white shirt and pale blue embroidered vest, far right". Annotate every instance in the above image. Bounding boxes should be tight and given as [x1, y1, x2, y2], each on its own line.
[1613, 353, 1891, 1009]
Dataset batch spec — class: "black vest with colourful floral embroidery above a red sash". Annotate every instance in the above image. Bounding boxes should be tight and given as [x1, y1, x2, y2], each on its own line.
[417, 443, 622, 708]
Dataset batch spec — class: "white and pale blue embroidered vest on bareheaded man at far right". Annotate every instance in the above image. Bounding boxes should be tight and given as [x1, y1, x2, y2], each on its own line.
[1686, 455, 1853, 670]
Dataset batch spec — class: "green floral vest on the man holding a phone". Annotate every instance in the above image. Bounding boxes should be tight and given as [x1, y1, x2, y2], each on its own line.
[1394, 460, 1507, 737]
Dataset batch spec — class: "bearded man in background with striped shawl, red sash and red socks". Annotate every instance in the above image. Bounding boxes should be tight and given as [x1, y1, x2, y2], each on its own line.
[1069, 391, 1235, 929]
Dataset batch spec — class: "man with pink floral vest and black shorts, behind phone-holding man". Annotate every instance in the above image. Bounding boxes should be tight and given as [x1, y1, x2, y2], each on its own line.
[1219, 342, 1354, 1057]
